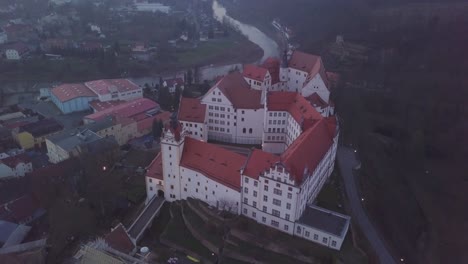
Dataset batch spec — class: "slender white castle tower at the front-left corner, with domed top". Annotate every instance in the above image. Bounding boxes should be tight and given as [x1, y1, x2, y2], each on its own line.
[161, 115, 186, 202]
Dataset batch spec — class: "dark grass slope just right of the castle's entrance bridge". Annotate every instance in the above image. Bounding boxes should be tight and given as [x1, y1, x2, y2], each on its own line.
[161, 203, 211, 259]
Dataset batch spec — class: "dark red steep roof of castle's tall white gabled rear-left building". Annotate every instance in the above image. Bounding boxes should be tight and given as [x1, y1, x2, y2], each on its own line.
[210, 72, 263, 109]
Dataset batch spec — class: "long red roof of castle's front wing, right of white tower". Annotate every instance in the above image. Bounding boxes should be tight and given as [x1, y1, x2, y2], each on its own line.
[180, 137, 246, 191]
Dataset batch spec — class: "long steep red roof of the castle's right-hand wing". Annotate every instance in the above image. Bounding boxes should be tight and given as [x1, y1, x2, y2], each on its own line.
[281, 119, 333, 184]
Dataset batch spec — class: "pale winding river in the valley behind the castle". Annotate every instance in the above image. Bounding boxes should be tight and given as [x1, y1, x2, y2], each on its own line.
[199, 0, 280, 80]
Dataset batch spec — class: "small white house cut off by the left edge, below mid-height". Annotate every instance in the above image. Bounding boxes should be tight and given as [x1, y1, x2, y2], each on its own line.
[0, 154, 33, 179]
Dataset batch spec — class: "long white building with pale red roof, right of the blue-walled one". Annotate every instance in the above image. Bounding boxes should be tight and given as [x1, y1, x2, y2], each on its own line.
[84, 79, 143, 102]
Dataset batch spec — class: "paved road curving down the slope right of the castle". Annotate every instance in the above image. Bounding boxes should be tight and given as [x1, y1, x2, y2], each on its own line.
[338, 147, 396, 264]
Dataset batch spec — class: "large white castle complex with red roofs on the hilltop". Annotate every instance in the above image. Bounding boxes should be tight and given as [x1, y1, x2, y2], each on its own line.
[146, 51, 350, 249]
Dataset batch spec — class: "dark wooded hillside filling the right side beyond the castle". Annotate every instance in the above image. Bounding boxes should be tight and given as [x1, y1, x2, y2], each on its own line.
[222, 0, 468, 263]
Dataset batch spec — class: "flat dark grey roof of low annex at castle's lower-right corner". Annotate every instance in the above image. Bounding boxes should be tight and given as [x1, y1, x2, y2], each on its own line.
[298, 206, 350, 237]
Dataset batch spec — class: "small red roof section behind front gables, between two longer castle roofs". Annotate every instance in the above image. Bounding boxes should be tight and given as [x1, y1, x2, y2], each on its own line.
[244, 149, 280, 180]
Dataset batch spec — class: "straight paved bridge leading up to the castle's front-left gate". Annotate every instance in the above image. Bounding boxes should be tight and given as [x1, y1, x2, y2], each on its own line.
[127, 197, 165, 240]
